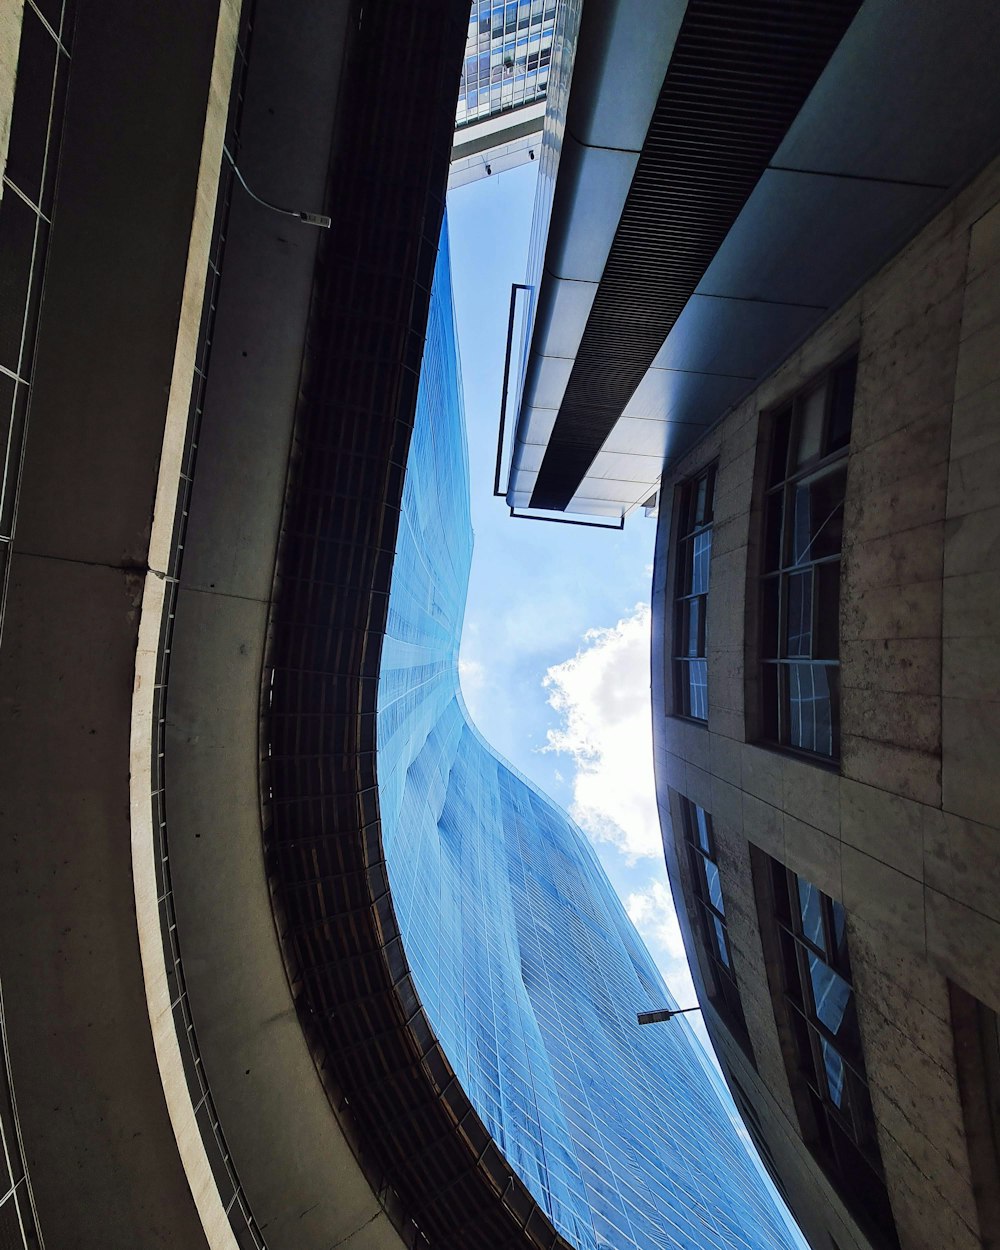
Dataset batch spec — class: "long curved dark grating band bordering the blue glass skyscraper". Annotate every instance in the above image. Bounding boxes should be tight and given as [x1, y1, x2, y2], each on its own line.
[260, 0, 569, 1250]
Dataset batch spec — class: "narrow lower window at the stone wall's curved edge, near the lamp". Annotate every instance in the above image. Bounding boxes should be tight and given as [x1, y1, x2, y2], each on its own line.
[680, 796, 753, 1061]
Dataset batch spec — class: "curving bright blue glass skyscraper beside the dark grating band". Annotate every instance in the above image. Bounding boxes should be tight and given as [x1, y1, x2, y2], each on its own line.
[378, 230, 799, 1250]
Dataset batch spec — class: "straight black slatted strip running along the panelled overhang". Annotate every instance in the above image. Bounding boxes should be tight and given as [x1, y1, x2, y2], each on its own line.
[531, 0, 860, 510]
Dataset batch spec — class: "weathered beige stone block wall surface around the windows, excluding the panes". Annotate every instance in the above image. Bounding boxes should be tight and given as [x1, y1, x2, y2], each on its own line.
[653, 148, 1000, 1250]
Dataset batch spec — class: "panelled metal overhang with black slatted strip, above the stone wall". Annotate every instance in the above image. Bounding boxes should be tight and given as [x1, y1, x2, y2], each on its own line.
[506, 0, 1000, 519]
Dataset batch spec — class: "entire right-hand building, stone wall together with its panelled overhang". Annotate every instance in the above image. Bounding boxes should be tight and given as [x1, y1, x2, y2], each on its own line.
[501, 0, 1000, 1250]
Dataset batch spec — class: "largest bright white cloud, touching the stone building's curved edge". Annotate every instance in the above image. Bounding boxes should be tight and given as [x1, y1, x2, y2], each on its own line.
[543, 604, 663, 864]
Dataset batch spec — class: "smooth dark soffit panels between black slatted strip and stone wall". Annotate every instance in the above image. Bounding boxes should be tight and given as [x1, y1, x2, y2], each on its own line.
[512, 0, 1000, 517]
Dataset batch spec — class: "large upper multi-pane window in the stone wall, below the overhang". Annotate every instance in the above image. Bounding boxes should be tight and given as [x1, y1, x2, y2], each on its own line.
[760, 358, 858, 759]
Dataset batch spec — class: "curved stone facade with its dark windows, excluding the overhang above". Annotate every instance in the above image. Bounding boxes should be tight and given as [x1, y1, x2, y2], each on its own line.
[653, 153, 1000, 1250]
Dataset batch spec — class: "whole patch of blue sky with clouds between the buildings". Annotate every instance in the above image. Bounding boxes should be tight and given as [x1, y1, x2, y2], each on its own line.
[449, 165, 700, 1031]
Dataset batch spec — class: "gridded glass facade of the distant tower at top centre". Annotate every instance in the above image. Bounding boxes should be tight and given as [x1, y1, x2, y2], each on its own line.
[455, 0, 556, 126]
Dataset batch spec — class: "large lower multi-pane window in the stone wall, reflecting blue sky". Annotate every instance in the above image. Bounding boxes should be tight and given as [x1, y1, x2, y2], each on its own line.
[761, 855, 898, 1245]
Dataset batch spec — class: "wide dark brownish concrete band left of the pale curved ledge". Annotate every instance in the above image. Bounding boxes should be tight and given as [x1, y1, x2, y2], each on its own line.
[0, 0, 230, 1250]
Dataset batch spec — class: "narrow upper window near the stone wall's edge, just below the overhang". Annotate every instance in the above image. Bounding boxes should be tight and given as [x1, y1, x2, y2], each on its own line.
[674, 465, 715, 720]
